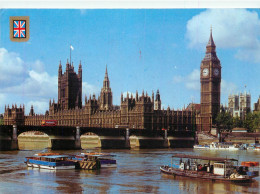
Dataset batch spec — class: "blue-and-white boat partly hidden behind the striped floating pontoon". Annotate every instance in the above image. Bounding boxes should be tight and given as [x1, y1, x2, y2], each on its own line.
[74, 152, 117, 168]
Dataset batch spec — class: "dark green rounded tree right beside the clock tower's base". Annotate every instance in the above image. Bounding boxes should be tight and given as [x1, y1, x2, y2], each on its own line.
[216, 111, 233, 132]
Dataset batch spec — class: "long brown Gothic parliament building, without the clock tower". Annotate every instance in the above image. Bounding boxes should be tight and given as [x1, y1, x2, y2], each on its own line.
[4, 63, 196, 130]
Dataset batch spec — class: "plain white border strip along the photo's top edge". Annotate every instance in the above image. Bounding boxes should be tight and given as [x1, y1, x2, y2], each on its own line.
[0, 0, 260, 9]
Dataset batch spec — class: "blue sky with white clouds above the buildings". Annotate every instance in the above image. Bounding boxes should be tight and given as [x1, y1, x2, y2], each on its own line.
[0, 9, 260, 114]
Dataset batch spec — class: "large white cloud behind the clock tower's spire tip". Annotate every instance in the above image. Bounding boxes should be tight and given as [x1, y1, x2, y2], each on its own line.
[186, 9, 260, 62]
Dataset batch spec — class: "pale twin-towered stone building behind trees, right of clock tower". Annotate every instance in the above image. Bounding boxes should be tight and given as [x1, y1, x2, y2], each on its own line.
[228, 92, 251, 119]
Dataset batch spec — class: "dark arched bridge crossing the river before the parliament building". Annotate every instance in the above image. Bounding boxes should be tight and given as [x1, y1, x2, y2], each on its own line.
[0, 125, 195, 150]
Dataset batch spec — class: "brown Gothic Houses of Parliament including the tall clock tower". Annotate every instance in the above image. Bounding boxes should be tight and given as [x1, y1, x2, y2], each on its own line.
[4, 32, 221, 131]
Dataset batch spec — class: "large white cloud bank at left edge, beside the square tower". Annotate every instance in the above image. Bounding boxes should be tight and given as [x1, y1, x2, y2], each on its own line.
[0, 48, 58, 113]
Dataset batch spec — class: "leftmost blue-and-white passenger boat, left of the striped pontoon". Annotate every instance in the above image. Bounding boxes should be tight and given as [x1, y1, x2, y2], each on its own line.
[24, 154, 75, 170]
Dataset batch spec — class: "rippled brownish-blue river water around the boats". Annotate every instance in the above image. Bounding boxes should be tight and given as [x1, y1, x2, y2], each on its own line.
[0, 149, 260, 194]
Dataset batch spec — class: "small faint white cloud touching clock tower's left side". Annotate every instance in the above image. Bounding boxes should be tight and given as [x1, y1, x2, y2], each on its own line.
[173, 69, 200, 90]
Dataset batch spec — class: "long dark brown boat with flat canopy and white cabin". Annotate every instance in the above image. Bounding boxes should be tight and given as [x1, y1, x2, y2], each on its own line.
[160, 154, 252, 182]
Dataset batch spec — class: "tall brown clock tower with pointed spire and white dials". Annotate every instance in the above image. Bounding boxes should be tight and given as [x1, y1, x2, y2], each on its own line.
[199, 29, 221, 131]
